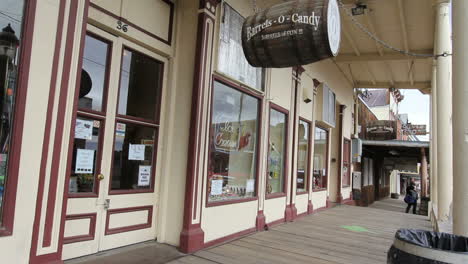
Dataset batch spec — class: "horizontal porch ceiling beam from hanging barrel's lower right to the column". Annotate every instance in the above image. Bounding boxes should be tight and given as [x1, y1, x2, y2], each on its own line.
[336, 50, 433, 63]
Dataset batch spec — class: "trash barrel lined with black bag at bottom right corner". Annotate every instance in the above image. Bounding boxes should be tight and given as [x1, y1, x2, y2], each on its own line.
[387, 229, 468, 264]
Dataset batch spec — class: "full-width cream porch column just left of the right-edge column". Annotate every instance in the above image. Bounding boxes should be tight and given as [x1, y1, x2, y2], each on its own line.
[434, 0, 453, 221]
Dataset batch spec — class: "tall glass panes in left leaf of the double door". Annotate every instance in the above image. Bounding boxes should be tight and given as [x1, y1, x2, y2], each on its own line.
[68, 34, 110, 195]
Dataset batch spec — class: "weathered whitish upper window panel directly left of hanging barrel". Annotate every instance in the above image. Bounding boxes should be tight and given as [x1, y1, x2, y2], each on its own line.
[218, 3, 264, 91]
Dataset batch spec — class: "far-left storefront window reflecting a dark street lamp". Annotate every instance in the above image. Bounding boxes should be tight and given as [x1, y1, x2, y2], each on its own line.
[0, 0, 25, 226]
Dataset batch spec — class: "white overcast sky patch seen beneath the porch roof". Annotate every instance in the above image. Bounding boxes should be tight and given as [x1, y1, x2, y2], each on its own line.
[399, 90, 430, 141]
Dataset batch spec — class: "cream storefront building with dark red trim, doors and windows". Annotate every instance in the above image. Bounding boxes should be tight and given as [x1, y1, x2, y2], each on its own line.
[0, 0, 357, 263]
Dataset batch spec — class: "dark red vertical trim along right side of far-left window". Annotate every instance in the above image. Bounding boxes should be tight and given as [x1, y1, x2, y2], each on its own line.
[0, 0, 37, 237]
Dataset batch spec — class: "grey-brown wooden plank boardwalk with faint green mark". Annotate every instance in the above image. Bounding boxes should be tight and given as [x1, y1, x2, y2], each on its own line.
[169, 201, 431, 264]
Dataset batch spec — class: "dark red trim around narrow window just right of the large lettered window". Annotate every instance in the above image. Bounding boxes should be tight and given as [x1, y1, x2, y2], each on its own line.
[265, 102, 289, 200]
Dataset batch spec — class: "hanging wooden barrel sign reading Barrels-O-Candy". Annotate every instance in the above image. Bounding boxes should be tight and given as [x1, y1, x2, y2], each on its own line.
[242, 0, 341, 68]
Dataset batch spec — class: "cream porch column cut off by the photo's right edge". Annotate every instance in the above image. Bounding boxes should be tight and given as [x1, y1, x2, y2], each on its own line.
[452, 0, 468, 236]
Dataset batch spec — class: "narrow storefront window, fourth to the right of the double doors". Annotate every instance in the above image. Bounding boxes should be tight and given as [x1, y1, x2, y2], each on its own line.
[312, 127, 328, 190]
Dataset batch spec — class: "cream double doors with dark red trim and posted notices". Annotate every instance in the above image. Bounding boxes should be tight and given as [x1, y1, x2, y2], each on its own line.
[63, 25, 167, 259]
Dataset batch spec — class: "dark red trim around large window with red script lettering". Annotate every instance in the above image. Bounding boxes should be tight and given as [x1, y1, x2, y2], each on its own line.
[205, 74, 263, 207]
